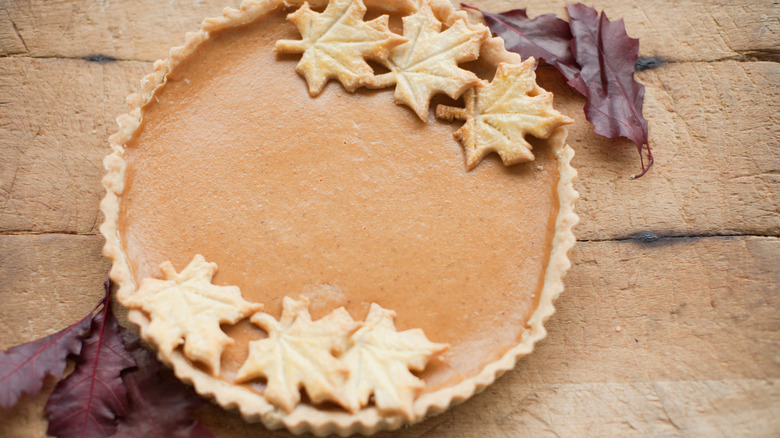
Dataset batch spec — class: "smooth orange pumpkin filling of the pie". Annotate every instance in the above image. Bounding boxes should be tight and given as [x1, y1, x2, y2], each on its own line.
[118, 3, 559, 408]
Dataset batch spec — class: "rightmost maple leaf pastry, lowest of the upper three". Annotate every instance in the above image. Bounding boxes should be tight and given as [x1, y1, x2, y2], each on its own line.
[436, 58, 574, 170]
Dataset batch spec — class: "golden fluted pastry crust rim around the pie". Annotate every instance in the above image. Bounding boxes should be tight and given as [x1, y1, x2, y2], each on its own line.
[100, 0, 578, 436]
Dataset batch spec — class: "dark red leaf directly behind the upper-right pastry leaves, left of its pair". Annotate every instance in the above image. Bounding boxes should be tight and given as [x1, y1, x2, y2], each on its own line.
[461, 5, 580, 79]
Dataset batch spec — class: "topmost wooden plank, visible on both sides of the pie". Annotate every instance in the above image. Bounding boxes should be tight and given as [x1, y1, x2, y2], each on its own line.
[0, 0, 780, 61]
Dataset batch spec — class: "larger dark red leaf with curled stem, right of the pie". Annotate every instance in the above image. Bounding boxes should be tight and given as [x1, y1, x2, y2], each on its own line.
[566, 3, 653, 177]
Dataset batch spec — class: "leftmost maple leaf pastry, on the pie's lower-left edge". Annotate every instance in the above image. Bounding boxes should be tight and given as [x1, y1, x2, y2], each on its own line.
[125, 254, 263, 375]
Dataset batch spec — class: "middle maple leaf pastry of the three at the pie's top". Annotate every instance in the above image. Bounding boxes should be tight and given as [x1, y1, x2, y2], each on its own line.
[368, 0, 490, 121]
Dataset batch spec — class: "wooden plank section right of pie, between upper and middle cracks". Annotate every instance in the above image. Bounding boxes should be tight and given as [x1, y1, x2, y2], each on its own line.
[539, 61, 780, 240]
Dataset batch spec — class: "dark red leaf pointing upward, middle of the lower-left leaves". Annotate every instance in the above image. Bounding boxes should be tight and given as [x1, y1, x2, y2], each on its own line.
[45, 282, 135, 438]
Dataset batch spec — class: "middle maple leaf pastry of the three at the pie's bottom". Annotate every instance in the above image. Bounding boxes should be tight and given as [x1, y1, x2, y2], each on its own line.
[236, 297, 359, 412]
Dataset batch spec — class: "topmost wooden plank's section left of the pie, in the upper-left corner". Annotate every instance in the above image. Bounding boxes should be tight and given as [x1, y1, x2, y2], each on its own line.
[0, 0, 230, 61]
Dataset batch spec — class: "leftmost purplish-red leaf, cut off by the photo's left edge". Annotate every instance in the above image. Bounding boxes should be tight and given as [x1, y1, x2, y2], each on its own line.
[0, 307, 97, 409]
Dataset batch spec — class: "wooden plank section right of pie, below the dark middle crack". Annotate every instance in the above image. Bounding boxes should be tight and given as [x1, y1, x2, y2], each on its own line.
[516, 237, 780, 384]
